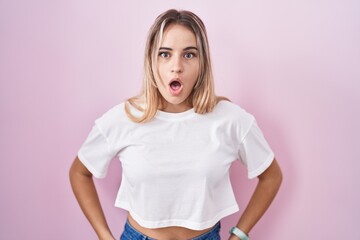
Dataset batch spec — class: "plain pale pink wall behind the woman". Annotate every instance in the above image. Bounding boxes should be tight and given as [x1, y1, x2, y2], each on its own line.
[0, 0, 360, 240]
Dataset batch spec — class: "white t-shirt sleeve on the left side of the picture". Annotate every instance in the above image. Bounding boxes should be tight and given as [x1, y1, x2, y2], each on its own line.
[78, 123, 116, 178]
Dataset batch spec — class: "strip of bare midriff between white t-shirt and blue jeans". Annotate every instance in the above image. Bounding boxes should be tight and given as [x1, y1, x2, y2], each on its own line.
[128, 214, 212, 240]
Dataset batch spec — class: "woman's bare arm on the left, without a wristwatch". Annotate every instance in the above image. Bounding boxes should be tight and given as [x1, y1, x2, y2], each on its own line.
[69, 157, 114, 240]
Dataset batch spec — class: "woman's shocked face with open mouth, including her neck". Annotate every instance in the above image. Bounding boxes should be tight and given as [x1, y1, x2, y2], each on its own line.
[155, 24, 200, 112]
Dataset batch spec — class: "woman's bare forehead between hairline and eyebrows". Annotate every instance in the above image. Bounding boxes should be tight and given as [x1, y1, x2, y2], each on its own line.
[160, 24, 196, 48]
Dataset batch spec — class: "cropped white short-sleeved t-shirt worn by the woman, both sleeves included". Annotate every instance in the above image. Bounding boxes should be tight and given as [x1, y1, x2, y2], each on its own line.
[78, 101, 274, 230]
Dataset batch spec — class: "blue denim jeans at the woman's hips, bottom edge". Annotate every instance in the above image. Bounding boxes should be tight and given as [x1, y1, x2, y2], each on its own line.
[120, 221, 221, 240]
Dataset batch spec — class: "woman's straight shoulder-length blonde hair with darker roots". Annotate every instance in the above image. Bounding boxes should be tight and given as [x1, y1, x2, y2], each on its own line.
[125, 9, 225, 123]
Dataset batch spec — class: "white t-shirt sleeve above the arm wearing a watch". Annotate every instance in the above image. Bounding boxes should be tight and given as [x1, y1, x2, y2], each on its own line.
[239, 120, 274, 179]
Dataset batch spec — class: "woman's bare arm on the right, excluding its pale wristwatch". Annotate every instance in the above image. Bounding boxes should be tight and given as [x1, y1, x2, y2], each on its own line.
[229, 159, 282, 240]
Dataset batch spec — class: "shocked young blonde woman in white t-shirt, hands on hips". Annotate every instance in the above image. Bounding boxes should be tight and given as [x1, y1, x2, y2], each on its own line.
[70, 10, 282, 240]
